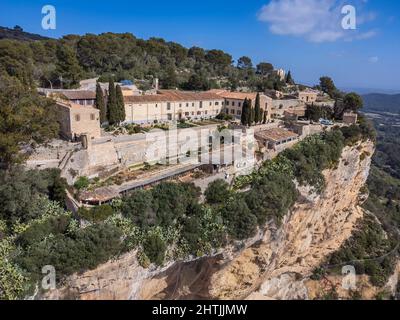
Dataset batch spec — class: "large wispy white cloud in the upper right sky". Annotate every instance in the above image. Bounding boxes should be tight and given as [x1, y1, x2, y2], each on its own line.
[258, 0, 376, 43]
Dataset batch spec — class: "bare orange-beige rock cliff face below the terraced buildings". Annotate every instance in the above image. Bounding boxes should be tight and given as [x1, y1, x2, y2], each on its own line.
[46, 142, 374, 299]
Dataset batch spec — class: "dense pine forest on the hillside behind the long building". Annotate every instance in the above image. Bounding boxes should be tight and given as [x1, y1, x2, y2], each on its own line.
[0, 28, 293, 90]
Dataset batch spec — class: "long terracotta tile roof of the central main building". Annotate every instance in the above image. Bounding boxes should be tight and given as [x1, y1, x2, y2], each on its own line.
[124, 90, 222, 103]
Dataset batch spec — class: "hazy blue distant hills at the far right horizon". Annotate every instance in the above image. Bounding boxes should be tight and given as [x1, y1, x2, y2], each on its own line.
[362, 93, 400, 113]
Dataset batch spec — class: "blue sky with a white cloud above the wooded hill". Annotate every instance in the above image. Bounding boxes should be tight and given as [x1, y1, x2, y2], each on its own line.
[0, 0, 400, 92]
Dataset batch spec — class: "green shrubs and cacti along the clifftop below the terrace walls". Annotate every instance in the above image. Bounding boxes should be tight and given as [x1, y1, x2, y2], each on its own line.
[0, 124, 373, 298]
